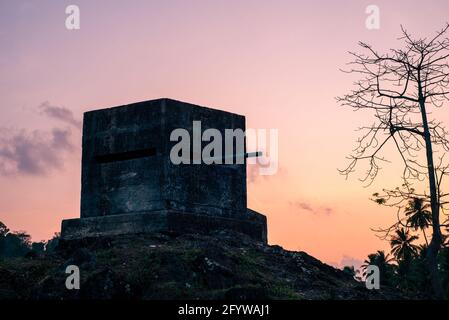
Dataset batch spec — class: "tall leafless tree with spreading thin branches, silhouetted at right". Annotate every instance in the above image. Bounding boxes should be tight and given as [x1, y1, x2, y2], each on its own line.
[337, 24, 449, 297]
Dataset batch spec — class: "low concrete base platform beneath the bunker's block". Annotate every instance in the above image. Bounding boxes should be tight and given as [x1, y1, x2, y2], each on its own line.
[61, 209, 267, 243]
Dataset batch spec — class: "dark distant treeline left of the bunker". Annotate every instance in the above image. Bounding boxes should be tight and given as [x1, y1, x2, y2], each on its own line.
[0, 221, 59, 258]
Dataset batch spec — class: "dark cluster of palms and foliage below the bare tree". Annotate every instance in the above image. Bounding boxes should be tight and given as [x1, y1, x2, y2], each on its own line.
[343, 194, 449, 298]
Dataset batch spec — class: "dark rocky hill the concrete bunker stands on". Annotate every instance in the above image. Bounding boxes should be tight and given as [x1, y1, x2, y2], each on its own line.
[0, 231, 401, 299]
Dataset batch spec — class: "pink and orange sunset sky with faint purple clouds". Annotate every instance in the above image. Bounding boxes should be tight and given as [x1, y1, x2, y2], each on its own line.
[0, 0, 449, 266]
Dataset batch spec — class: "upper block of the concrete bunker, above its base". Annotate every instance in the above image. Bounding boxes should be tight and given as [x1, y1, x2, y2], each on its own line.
[81, 99, 246, 218]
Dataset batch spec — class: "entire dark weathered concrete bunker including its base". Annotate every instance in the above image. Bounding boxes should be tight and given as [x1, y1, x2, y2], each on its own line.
[62, 99, 267, 242]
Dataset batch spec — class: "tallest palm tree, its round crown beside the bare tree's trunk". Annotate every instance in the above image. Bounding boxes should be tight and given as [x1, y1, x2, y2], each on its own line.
[404, 197, 432, 245]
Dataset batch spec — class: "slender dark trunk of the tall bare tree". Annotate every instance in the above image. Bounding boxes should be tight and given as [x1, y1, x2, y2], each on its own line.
[418, 91, 444, 299]
